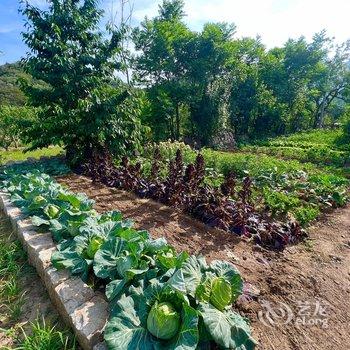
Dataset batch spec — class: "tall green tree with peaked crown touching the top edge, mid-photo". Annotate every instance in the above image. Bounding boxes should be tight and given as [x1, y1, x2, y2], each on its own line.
[133, 0, 193, 140]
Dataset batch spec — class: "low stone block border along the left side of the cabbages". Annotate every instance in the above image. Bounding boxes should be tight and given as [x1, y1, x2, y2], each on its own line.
[0, 191, 108, 350]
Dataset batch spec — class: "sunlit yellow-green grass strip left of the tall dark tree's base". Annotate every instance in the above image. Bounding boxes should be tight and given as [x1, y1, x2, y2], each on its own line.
[0, 146, 63, 165]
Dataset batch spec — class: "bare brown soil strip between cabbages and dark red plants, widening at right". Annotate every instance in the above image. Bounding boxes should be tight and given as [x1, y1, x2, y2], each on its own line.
[59, 175, 350, 350]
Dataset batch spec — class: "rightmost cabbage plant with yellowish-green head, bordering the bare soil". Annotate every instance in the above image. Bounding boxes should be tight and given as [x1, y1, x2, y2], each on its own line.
[168, 256, 256, 349]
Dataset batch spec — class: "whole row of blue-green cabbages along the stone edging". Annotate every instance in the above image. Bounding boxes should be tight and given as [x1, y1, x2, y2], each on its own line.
[2, 172, 256, 350]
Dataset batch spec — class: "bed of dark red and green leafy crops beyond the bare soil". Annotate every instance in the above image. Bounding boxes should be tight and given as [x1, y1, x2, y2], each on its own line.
[81, 142, 349, 249]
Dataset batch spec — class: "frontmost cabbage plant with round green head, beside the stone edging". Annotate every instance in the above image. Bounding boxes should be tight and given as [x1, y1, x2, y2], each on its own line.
[104, 281, 199, 350]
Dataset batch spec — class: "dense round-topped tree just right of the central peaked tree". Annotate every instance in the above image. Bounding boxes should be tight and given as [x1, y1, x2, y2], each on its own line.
[187, 23, 237, 146]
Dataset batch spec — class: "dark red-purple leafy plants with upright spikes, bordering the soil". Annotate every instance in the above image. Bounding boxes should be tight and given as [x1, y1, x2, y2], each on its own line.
[85, 149, 305, 249]
